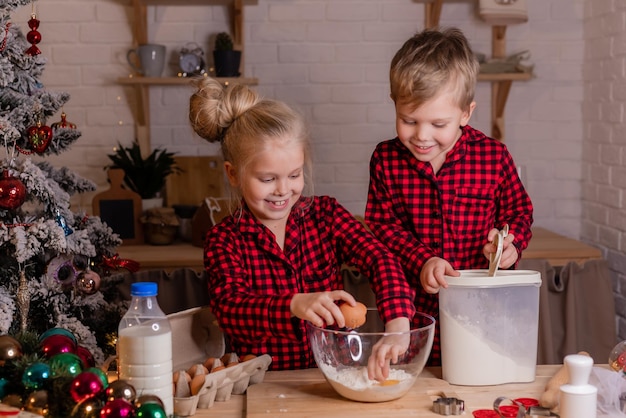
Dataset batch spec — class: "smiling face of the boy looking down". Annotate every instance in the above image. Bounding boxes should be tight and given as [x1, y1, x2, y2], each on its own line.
[396, 84, 476, 173]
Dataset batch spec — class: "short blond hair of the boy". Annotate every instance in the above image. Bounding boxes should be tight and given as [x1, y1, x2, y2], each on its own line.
[389, 28, 479, 110]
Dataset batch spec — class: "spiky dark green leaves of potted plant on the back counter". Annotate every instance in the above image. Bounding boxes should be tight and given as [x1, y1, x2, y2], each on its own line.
[105, 141, 181, 210]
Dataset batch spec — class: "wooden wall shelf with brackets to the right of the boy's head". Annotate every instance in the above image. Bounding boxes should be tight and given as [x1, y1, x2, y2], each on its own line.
[418, 0, 533, 141]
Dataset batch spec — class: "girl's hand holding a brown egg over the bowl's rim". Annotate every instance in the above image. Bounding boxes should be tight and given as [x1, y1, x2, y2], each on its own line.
[289, 290, 356, 328]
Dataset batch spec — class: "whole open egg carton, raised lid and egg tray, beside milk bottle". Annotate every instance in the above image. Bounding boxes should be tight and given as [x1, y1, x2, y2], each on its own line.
[168, 307, 272, 417]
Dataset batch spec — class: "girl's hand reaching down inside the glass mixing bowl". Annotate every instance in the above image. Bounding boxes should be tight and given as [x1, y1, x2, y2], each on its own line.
[367, 318, 411, 382]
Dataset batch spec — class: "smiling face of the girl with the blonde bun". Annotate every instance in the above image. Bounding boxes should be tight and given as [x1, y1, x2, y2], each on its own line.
[225, 138, 304, 229]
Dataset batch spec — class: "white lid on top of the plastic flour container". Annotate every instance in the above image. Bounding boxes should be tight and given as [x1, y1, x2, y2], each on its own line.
[446, 269, 541, 287]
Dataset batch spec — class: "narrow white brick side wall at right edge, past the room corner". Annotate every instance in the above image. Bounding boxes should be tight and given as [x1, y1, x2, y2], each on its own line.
[581, 0, 626, 340]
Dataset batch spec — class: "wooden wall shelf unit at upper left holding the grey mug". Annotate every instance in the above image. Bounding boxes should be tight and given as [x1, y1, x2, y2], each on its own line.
[117, 0, 258, 156]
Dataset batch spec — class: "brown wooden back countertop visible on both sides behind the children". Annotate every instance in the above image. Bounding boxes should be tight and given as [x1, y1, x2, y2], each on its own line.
[118, 227, 602, 271]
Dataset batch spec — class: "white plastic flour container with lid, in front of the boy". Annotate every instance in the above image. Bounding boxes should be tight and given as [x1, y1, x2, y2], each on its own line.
[439, 270, 541, 386]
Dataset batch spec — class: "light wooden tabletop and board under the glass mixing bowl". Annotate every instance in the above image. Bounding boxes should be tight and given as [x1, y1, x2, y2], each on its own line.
[194, 365, 568, 418]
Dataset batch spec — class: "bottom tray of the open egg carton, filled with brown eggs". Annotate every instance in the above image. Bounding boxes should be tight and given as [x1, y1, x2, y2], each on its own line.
[174, 354, 272, 417]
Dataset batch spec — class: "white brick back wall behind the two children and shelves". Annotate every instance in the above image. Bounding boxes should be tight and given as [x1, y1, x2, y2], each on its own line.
[26, 0, 584, 235]
